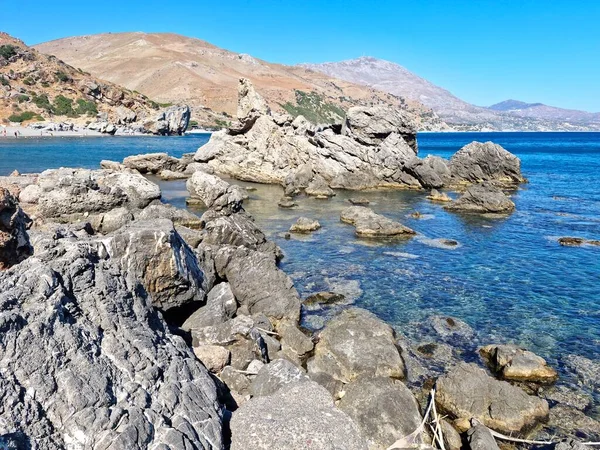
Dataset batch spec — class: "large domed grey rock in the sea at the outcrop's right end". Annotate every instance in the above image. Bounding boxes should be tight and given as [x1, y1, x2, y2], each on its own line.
[449, 141, 525, 183]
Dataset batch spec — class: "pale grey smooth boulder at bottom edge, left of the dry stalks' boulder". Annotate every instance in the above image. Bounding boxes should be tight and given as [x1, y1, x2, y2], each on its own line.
[231, 381, 367, 450]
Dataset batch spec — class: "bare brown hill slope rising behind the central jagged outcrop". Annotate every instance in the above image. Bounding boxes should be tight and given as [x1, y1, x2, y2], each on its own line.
[36, 33, 445, 129]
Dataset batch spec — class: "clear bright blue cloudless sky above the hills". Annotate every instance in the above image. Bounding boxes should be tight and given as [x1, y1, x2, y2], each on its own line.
[0, 0, 600, 112]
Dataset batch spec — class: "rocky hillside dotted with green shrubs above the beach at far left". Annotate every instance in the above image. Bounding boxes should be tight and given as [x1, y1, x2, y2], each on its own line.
[0, 33, 169, 130]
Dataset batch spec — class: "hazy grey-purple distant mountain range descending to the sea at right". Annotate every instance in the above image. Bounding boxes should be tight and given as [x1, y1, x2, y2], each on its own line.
[301, 57, 600, 131]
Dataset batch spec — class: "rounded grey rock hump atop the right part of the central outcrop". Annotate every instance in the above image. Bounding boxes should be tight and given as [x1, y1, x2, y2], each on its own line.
[342, 105, 417, 153]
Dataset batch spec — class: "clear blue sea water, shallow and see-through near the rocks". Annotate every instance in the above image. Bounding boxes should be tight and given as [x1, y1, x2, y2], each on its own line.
[0, 133, 600, 366]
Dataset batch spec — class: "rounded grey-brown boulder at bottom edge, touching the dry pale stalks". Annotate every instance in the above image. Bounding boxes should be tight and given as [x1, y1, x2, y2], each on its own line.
[338, 377, 421, 449]
